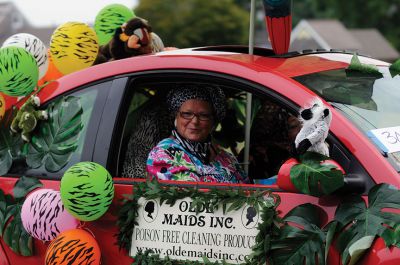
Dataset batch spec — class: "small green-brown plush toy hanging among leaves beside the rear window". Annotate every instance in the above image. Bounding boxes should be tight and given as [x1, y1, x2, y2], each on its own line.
[11, 96, 48, 142]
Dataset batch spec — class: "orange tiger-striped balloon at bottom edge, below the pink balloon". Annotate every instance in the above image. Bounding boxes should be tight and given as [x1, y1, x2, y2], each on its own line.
[45, 229, 101, 265]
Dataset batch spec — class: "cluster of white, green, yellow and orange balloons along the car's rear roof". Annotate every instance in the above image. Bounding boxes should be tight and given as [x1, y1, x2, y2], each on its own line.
[0, 4, 135, 104]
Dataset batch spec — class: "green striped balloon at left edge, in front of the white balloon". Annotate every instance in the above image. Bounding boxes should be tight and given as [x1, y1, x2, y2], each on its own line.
[0, 46, 39, 97]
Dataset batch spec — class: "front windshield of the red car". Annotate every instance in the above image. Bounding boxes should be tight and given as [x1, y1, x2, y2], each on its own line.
[294, 67, 400, 171]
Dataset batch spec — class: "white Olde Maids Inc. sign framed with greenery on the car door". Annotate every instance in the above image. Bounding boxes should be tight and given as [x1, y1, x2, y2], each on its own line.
[130, 198, 261, 264]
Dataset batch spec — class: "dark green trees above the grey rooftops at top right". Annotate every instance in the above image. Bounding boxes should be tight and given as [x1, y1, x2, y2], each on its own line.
[292, 0, 400, 50]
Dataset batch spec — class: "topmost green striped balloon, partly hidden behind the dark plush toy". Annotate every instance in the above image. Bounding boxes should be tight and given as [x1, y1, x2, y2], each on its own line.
[94, 4, 135, 45]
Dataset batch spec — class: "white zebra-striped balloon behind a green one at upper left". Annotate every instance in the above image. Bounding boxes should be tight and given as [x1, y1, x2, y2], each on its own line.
[3, 33, 49, 79]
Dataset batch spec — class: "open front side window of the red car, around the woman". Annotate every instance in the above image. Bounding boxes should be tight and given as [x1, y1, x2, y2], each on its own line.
[117, 76, 299, 182]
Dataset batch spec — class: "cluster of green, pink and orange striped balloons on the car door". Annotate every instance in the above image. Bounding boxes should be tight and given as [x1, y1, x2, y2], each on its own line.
[21, 162, 114, 265]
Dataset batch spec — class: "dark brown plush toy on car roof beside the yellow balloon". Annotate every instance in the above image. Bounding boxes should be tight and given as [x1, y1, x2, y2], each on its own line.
[94, 17, 152, 65]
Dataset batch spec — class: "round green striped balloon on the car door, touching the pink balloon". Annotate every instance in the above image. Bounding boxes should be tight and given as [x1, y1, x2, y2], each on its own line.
[60, 162, 114, 221]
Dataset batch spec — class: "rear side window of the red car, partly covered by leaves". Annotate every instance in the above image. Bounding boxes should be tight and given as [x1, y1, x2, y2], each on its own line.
[9, 83, 107, 178]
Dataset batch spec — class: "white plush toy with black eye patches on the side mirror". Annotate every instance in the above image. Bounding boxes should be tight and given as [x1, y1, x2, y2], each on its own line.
[295, 98, 332, 156]
